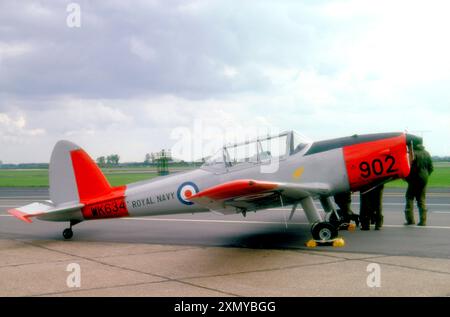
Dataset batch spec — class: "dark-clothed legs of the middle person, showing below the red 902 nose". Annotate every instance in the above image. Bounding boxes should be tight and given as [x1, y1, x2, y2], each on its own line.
[359, 184, 384, 230]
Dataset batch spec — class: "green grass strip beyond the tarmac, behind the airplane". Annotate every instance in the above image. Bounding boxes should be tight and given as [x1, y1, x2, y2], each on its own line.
[0, 163, 450, 188]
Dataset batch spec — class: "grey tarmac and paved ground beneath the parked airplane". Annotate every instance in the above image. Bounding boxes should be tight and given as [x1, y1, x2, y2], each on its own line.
[0, 188, 450, 296]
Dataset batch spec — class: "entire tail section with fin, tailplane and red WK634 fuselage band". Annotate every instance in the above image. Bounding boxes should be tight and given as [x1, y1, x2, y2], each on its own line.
[8, 141, 128, 222]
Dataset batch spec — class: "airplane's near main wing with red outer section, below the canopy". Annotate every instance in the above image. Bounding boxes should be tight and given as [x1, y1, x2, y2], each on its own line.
[189, 179, 330, 214]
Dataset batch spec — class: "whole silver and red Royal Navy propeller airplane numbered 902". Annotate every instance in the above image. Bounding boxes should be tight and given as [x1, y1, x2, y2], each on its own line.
[8, 131, 421, 241]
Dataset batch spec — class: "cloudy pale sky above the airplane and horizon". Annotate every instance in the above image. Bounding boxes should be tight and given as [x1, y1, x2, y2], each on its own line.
[0, 0, 450, 163]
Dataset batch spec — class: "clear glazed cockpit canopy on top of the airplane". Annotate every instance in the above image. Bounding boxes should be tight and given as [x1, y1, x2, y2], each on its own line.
[202, 131, 312, 170]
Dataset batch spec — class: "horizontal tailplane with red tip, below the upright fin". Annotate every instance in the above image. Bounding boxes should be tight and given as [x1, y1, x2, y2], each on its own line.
[8, 201, 84, 222]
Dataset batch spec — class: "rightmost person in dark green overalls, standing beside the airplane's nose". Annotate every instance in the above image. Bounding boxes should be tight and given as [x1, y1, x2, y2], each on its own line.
[405, 144, 433, 226]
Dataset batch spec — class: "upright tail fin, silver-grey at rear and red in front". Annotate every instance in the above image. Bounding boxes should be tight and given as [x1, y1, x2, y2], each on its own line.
[49, 141, 112, 205]
